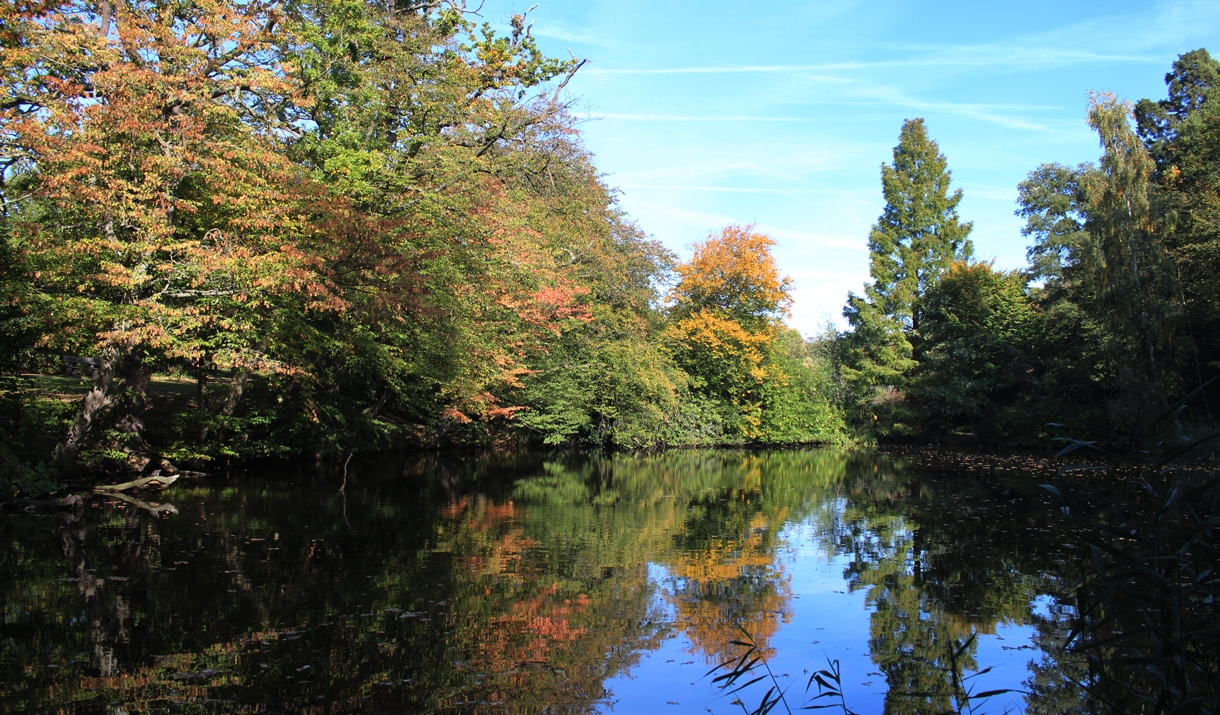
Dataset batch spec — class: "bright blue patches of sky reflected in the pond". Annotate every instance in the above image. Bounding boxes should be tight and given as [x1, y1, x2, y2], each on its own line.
[600, 514, 1039, 715]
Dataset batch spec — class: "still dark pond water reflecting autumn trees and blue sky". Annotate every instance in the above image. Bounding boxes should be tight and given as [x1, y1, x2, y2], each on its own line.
[0, 450, 1080, 714]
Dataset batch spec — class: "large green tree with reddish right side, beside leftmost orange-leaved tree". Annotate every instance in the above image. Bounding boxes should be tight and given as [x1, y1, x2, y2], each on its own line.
[226, 1, 587, 450]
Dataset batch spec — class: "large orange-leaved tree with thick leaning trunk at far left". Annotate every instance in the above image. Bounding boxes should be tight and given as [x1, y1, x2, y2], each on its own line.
[0, 0, 339, 466]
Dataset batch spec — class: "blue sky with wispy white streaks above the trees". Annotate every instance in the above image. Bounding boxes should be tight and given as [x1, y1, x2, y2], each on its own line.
[481, 0, 1220, 336]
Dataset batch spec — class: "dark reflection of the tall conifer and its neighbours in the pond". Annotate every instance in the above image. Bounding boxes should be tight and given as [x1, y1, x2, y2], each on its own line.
[824, 463, 1058, 714]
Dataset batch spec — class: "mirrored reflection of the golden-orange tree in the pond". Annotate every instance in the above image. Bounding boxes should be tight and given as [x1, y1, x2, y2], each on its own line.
[621, 450, 871, 665]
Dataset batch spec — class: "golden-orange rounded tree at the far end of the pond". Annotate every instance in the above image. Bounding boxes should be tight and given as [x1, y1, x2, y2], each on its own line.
[667, 226, 792, 439]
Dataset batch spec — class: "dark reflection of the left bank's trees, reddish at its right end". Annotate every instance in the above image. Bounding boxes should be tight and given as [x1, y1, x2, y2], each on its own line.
[0, 461, 662, 713]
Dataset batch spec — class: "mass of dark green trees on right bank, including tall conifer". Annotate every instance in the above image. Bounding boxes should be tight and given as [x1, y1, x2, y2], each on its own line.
[832, 50, 1220, 444]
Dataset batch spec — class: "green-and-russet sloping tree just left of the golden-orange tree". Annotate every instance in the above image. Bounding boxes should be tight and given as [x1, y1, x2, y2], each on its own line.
[506, 137, 689, 448]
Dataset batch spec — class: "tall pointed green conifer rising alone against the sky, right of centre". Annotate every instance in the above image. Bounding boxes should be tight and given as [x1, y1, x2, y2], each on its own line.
[843, 118, 972, 387]
